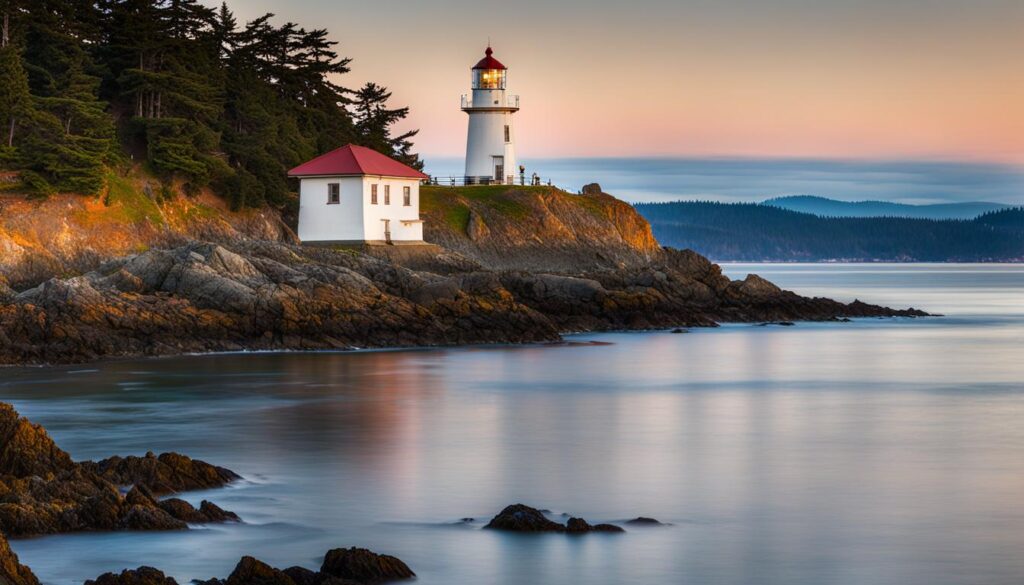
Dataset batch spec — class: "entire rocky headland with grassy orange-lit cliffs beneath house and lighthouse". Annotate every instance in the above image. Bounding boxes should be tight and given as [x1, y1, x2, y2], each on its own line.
[0, 181, 924, 364]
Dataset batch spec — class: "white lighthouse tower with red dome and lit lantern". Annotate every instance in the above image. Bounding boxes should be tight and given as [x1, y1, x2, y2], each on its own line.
[462, 46, 519, 184]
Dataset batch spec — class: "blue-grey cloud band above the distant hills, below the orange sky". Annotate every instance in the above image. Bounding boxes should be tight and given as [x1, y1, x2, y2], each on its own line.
[425, 156, 1024, 205]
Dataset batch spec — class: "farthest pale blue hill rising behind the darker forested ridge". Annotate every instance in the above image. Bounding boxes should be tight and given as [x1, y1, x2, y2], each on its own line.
[762, 195, 1011, 219]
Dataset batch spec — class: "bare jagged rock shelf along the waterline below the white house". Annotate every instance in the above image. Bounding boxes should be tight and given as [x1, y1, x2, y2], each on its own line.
[0, 241, 924, 364]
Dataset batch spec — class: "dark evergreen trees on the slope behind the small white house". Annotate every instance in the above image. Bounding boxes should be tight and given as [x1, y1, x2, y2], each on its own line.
[0, 0, 423, 208]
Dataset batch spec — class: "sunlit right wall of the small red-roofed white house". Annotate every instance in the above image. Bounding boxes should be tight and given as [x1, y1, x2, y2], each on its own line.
[362, 176, 423, 242]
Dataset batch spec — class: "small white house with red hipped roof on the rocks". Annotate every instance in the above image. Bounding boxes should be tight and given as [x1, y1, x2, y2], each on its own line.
[288, 144, 429, 245]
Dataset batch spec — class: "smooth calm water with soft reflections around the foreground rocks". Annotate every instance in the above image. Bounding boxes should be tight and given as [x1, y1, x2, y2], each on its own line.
[0, 264, 1024, 585]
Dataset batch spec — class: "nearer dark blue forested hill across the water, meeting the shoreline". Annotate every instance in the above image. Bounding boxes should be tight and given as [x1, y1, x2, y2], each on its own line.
[636, 202, 1024, 262]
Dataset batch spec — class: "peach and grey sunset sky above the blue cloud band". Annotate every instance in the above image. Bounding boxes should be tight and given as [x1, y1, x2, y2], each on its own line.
[204, 0, 1024, 199]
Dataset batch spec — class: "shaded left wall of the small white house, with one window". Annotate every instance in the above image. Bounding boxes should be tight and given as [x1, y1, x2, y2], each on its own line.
[299, 176, 366, 242]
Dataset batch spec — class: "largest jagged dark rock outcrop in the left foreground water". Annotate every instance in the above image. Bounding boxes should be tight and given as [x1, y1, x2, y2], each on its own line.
[0, 403, 239, 537]
